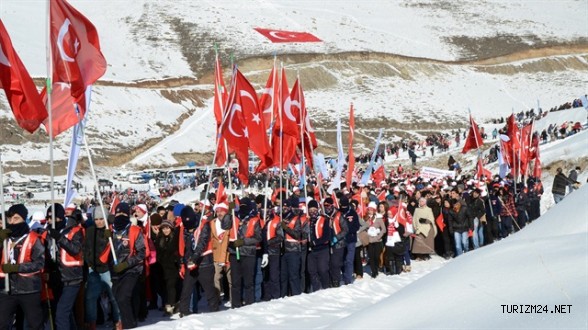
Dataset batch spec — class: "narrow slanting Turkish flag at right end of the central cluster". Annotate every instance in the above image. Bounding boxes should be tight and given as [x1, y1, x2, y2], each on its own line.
[290, 79, 318, 169]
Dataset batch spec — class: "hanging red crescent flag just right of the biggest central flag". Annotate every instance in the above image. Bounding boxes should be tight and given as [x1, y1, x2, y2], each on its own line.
[272, 68, 300, 170]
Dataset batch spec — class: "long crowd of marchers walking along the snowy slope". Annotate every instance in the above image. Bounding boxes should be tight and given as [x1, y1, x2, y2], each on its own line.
[0, 156, 580, 329]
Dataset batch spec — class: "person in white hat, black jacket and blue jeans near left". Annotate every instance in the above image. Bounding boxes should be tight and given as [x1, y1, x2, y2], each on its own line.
[83, 206, 122, 329]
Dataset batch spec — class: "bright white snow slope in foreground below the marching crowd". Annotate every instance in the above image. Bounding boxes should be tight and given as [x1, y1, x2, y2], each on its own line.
[131, 187, 588, 330]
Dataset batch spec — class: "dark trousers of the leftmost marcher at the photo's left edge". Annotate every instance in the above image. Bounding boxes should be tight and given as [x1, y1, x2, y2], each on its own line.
[0, 292, 43, 330]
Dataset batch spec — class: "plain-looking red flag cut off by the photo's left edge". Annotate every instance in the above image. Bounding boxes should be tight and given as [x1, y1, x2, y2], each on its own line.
[0, 20, 47, 133]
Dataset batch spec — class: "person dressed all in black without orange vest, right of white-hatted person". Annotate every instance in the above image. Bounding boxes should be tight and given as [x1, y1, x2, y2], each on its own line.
[153, 220, 180, 316]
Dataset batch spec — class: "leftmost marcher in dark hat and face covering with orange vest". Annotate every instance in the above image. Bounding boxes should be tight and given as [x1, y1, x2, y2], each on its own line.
[0, 204, 45, 330]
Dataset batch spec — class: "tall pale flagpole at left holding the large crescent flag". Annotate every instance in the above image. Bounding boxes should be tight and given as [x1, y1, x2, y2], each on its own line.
[45, 0, 56, 260]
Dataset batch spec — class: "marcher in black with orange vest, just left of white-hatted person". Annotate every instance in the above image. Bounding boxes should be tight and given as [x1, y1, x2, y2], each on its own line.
[49, 205, 84, 329]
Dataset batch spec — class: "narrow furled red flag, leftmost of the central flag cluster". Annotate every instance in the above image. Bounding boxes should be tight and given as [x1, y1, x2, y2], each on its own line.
[213, 55, 228, 166]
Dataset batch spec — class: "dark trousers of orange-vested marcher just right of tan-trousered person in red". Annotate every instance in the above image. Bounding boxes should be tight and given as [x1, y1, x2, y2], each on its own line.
[229, 254, 255, 308]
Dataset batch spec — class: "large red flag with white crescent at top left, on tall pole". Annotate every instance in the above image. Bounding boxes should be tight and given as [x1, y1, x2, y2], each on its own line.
[44, 0, 106, 136]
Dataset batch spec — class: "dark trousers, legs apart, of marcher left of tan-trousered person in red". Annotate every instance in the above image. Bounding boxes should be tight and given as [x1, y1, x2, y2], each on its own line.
[180, 265, 220, 315]
